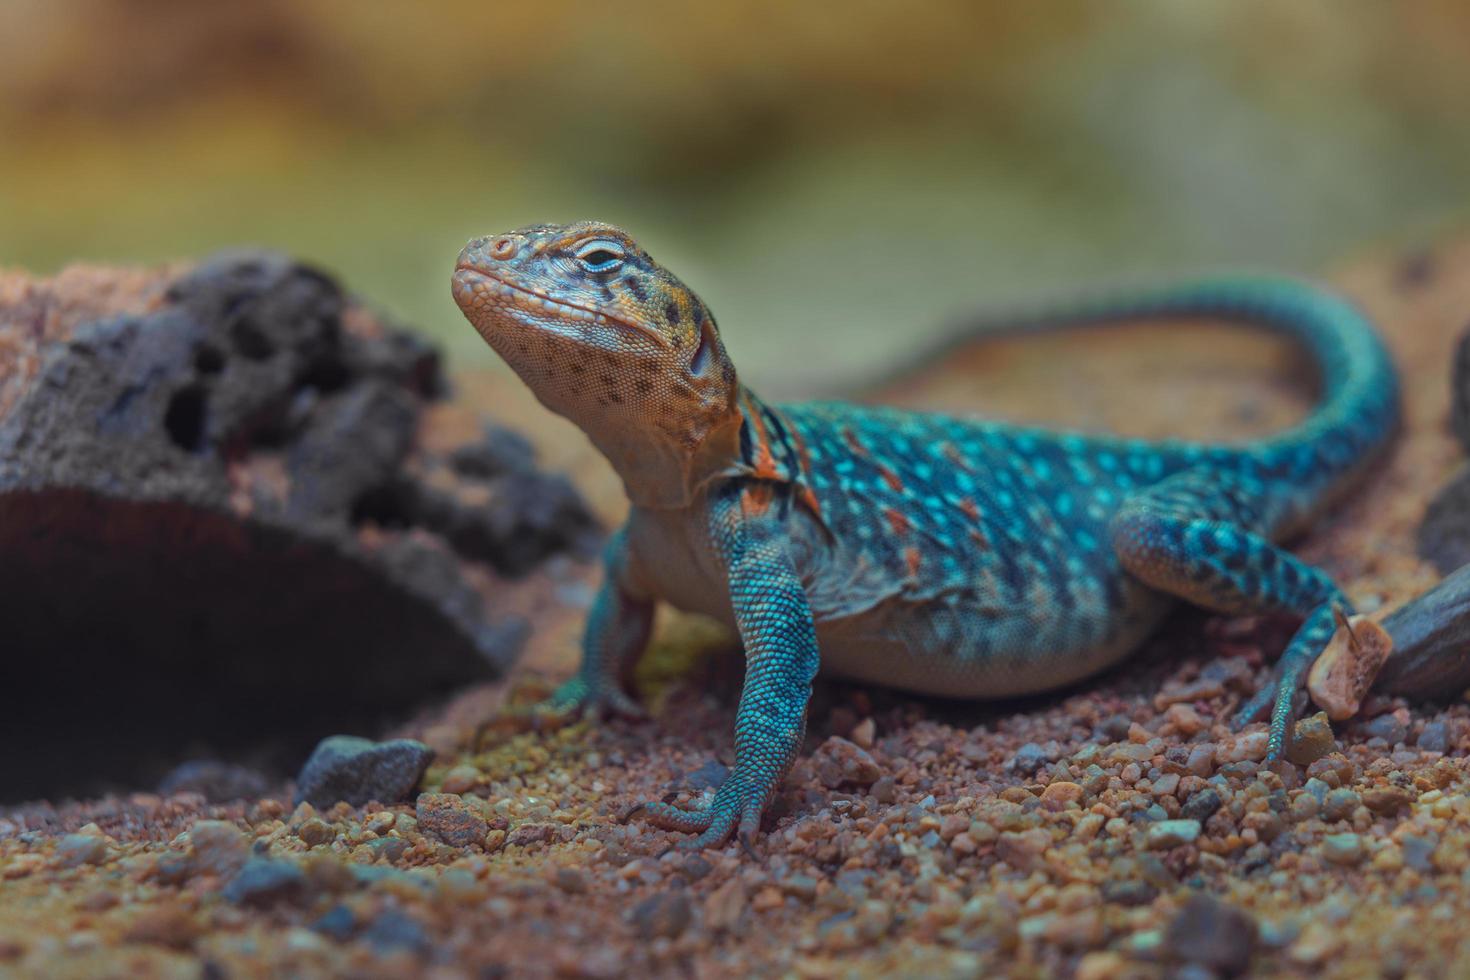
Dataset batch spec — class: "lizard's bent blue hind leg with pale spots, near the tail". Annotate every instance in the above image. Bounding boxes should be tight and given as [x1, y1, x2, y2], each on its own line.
[1110, 472, 1351, 760]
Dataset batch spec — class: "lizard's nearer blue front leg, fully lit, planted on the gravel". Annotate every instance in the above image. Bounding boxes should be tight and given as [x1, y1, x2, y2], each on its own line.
[639, 488, 817, 849]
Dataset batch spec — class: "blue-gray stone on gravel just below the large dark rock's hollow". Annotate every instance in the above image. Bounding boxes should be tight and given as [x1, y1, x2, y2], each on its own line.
[295, 735, 434, 810]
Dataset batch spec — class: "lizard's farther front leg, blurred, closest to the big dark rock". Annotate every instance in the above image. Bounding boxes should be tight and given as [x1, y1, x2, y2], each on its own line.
[548, 526, 653, 717]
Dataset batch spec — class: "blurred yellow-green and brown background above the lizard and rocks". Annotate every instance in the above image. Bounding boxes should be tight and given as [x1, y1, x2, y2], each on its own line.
[0, 0, 1470, 394]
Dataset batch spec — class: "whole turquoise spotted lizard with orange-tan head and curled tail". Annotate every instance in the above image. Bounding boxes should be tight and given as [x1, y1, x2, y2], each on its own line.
[454, 222, 1398, 848]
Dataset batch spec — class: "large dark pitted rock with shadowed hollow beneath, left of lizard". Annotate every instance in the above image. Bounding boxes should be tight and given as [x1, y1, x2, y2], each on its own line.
[0, 253, 597, 801]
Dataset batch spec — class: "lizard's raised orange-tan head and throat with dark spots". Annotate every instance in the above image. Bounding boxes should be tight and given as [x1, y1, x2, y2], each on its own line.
[453, 222, 741, 507]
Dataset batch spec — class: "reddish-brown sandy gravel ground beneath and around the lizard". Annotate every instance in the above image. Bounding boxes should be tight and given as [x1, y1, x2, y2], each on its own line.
[0, 244, 1470, 980]
